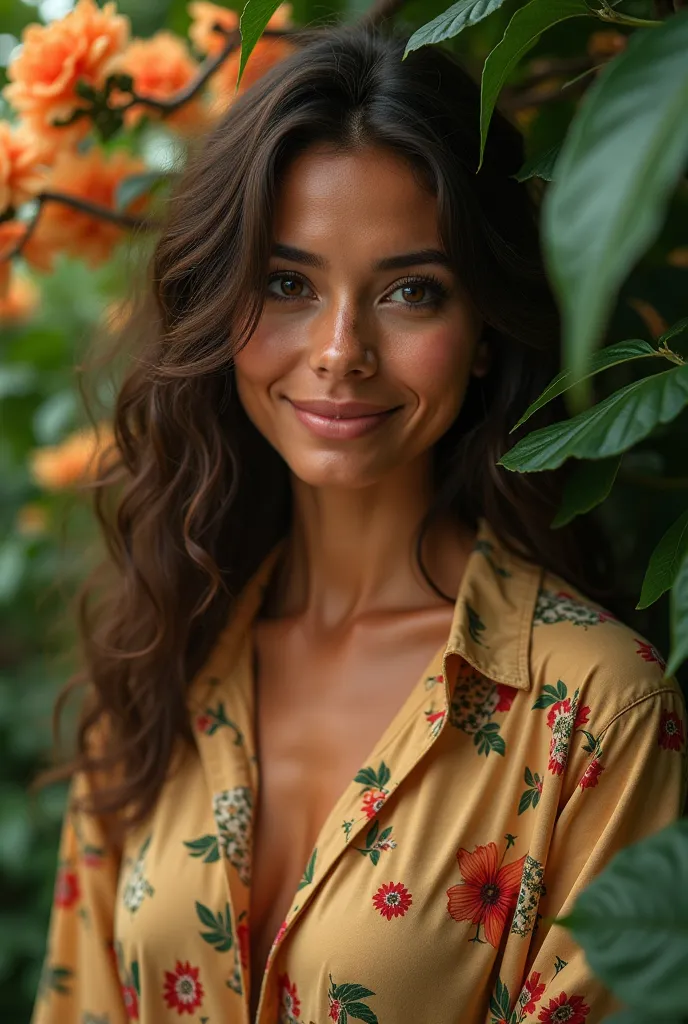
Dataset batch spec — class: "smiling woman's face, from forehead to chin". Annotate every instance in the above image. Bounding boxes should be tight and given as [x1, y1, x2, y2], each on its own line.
[235, 146, 487, 487]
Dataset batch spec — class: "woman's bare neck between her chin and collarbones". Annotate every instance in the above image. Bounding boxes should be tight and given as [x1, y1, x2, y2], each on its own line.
[264, 460, 474, 629]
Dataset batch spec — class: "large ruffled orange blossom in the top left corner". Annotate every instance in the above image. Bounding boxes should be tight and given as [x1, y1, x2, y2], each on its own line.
[4, 0, 129, 152]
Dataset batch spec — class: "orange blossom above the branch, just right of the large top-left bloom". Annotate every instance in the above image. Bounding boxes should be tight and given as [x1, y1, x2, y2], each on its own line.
[108, 31, 206, 130]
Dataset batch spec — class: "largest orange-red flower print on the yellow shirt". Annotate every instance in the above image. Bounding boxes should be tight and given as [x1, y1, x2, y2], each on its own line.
[446, 837, 525, 948]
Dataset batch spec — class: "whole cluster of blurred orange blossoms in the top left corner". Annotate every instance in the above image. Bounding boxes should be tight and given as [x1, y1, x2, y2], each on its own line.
[0, 0, 291, 311]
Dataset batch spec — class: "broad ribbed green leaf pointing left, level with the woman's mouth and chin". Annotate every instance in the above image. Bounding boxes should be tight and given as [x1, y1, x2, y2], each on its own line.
[499, 366, 688, 473]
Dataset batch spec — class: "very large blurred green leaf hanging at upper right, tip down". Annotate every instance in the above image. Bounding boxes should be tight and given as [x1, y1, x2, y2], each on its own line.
[543, 10, 688, 385]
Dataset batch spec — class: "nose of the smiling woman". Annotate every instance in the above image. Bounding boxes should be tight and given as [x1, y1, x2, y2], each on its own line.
[309, 309, 378, 379]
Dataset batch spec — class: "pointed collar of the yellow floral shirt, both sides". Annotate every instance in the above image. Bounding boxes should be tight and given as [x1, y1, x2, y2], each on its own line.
[204, 518, 543, 690]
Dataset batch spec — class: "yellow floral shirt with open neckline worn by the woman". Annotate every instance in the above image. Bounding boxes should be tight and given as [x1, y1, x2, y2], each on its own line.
[32, 521, 686, 1024]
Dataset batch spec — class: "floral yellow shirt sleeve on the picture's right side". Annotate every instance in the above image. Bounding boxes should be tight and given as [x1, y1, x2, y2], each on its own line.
[509, 689, 686, 1024]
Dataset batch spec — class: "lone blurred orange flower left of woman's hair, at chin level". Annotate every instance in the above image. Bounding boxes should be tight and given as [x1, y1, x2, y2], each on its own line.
[30, 424, 117, 490]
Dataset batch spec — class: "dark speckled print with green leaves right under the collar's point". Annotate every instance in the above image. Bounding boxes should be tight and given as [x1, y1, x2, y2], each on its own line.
[449, 662, 513, 757]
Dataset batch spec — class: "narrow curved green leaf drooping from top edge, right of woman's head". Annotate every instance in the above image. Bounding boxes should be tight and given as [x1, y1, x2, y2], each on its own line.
[478, 0, 591, 168]
